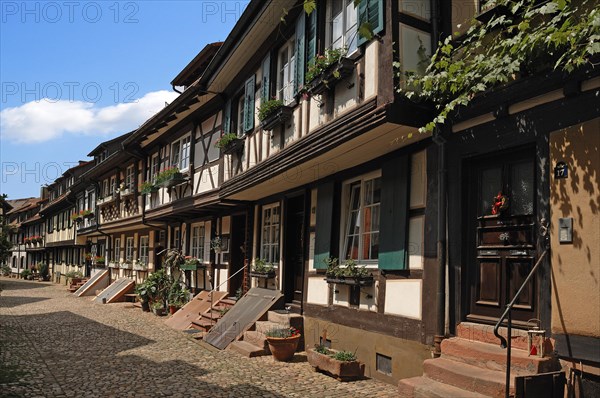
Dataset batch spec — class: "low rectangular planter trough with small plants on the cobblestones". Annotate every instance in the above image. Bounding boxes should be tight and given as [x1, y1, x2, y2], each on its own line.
[306, 345, 365, 381]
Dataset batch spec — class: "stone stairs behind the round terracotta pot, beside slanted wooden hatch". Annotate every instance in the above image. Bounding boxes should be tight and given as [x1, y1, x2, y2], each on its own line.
[228, 310, 304, 357]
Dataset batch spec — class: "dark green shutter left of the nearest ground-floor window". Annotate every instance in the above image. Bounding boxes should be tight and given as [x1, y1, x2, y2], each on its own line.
[314, 182, 334, 269]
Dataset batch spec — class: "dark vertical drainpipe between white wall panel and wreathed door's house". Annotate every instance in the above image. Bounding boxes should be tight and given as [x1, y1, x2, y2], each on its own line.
[433, 126, 448, 357]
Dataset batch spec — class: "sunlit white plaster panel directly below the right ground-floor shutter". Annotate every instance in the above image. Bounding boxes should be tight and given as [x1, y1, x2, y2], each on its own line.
[384, 279, 423, 319]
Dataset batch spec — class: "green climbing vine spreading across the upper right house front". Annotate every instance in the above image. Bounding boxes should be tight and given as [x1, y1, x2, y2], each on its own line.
[395, 0, 600, 132]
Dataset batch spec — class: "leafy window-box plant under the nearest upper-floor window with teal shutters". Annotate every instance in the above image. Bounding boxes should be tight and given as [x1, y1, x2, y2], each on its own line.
[305, 48, 354, 94]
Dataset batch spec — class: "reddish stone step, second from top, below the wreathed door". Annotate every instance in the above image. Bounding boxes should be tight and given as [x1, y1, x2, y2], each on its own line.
[442, 337, 560, 376]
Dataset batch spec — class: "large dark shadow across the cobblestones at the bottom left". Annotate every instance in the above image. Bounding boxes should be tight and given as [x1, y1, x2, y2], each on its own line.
[0, 311, 288, 398]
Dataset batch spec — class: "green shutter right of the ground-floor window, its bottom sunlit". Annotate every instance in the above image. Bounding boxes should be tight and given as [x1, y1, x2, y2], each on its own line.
[379, 155, 410, 270]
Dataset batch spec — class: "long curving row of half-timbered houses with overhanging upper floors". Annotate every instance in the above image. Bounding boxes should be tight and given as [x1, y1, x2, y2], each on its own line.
[2, 0, 600, 392]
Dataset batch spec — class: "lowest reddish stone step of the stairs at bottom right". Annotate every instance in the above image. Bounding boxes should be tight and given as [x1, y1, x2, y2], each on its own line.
[398, 376, 487, 398]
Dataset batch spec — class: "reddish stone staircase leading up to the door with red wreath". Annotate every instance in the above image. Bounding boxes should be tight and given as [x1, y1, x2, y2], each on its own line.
[398, 324, 560, 398]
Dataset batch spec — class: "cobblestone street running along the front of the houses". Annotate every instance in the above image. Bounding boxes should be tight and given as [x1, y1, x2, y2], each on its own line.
[0, 277, 404, 398]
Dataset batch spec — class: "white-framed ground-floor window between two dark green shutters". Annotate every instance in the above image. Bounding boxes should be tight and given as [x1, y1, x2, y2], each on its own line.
[341, 176, 381, 261]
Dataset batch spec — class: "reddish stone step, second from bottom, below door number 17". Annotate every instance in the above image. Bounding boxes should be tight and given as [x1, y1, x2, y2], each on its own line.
[423, 358, 514, 398]
